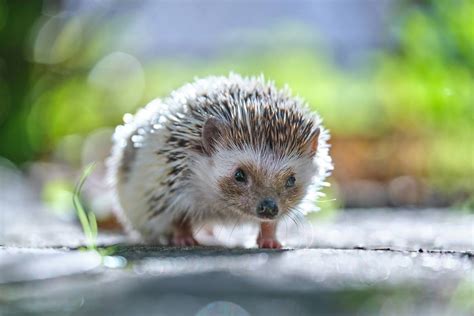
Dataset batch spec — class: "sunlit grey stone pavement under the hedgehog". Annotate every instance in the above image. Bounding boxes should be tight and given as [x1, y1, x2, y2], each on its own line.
[0, 167, 474, 316]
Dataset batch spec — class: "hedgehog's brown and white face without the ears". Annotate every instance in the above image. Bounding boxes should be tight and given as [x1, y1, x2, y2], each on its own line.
[211, 149, 316, 221]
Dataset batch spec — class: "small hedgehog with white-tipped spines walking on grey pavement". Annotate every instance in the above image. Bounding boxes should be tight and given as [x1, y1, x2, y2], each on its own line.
[107, 73, 332, 248]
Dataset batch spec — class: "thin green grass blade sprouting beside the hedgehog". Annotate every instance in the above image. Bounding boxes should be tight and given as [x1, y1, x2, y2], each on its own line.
[72, 163, 98, 252]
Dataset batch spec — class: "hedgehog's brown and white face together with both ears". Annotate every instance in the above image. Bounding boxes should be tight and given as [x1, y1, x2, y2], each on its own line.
[196, 118, 319, 221]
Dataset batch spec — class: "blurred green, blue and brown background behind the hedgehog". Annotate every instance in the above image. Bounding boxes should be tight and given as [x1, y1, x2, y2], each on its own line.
[0, 0, 474, 228]
